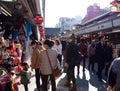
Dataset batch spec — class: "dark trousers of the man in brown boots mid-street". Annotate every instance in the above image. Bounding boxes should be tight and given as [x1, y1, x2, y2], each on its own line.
[67, 65, 76, 84]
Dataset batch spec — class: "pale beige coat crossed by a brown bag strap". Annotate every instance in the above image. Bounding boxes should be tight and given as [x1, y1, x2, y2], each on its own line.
[40, 49, 59, 75]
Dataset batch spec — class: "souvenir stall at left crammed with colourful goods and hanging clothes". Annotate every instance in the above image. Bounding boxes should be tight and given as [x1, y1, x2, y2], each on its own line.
[0, 1, 40, 91]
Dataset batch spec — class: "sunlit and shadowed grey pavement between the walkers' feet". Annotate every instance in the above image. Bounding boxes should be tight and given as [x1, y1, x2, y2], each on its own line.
[19, 60, 107, 91]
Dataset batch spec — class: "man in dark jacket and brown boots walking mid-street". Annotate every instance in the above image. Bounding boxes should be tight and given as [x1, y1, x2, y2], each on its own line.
[64, 33, 78, 91]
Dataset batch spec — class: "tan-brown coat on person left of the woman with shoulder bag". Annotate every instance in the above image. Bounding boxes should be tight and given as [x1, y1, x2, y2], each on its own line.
[31, 45, 41, 69]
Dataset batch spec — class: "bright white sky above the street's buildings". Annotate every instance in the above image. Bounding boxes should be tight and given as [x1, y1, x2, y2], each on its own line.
[45, 0, 113, 27]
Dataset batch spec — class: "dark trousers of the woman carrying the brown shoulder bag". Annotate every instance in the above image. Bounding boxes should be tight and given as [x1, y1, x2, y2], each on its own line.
[41, 74, 56, 91]
